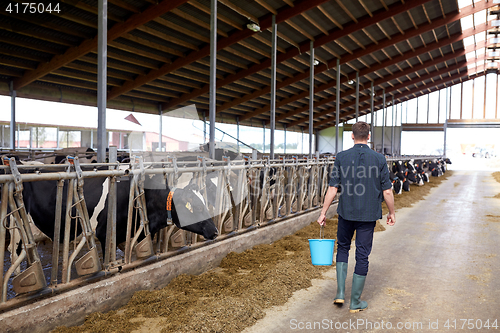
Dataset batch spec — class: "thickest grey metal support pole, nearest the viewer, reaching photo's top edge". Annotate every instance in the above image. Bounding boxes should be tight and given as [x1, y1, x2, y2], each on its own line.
[97, 0, 108, 163]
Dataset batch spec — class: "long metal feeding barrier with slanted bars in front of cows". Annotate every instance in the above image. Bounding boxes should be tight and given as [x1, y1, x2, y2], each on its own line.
[0, 156, 334, 310]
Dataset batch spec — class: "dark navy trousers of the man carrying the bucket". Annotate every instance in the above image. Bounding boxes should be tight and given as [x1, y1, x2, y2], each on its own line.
[337, 215, 376, 276]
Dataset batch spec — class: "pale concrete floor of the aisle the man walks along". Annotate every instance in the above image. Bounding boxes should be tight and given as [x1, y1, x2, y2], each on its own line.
[244, 170, 500, 333]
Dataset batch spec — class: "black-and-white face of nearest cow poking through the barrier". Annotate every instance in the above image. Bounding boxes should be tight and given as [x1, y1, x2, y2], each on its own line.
[173, 186, 219, 239]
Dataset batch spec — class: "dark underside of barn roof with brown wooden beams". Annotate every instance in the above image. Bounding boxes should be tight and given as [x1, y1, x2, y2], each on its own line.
[0, 0, 493, 130]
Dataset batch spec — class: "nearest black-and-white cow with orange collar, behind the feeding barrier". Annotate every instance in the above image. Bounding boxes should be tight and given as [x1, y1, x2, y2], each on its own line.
[18, 167, 218, 264]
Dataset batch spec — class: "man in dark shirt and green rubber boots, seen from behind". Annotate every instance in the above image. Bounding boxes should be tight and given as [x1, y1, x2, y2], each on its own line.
[318, 121, 396, 313]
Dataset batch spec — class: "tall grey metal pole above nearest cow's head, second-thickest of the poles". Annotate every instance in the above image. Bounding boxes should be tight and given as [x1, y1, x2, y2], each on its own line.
[208, 0, 217, 159]
